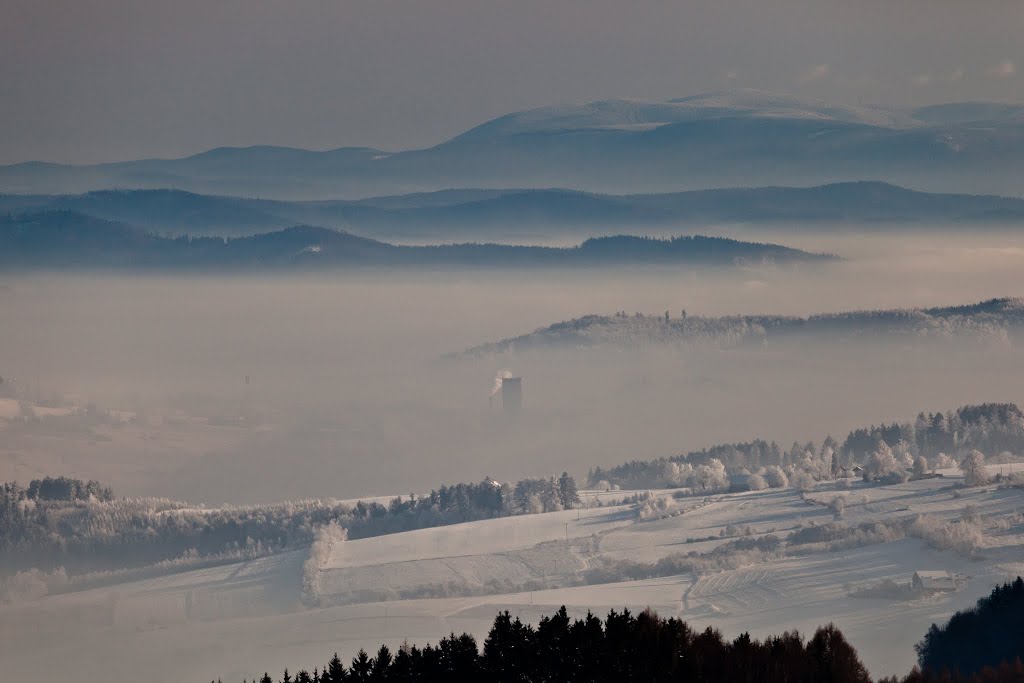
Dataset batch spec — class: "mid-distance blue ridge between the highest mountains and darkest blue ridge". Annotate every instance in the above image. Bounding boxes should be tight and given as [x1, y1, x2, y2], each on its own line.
[0, 182, 1024, 241]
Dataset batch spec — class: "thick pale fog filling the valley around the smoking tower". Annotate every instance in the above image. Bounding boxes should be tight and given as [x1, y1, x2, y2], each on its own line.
[0, 231, 1024, 503]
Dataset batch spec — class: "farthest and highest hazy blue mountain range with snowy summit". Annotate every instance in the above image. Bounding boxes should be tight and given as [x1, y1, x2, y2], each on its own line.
[6, 90, 1024, 199]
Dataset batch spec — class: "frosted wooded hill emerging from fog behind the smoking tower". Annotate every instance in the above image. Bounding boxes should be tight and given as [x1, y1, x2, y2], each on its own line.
[450, 298, 1024, 358]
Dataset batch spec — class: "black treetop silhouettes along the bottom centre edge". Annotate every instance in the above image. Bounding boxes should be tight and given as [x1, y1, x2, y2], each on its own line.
[243, 607, 870, 683]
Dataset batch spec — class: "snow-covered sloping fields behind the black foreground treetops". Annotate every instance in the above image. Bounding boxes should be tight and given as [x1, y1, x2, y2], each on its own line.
[0, 465, 1024, 682]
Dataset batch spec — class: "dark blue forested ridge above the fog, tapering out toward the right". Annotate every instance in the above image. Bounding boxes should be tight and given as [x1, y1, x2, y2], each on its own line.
[0, 211, 835, 271]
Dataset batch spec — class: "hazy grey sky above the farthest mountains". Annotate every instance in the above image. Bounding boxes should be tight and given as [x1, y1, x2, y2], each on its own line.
[0, 0, 1024, 163]
